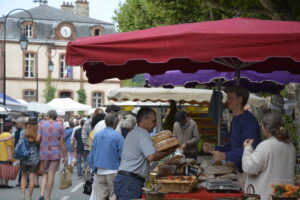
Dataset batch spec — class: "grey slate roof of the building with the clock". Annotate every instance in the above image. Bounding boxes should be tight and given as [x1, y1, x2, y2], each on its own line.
[0, 5, 116, 41]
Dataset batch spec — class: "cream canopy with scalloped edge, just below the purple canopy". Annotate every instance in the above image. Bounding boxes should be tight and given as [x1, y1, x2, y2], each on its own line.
[108, 87, 267, 107]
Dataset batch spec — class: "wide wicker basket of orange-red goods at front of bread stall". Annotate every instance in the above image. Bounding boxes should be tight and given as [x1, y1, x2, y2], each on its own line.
[155, 177, 197, 193]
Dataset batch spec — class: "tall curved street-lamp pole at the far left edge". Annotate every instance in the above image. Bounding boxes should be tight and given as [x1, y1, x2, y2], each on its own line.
[3, 8, 33, 107]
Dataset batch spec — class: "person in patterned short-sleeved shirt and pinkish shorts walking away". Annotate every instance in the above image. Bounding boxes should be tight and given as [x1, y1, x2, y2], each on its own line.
[37, 110, 68, 200]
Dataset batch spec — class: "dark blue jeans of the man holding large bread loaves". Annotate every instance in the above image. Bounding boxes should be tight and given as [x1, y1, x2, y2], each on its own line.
[114, 174, 144, 200]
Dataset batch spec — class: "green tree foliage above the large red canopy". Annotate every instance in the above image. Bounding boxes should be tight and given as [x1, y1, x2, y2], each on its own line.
[114, 0, 300, 32]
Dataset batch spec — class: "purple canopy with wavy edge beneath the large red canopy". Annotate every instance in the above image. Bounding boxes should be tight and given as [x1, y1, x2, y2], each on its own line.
[145, 70, 300, 94]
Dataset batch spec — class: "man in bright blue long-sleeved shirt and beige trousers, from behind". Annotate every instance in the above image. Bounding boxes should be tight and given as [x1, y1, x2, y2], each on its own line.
[91, 112, 124, 200]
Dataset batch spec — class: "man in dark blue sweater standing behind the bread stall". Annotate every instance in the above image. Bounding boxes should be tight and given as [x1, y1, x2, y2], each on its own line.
[203, 86, 261, 188]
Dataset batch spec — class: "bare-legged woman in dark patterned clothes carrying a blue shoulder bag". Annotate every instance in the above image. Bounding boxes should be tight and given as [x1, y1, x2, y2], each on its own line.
[19, 118, 40, 200]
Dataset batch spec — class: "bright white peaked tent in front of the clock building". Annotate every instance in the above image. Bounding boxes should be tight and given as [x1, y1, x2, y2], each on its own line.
[47, 98, 91, 112]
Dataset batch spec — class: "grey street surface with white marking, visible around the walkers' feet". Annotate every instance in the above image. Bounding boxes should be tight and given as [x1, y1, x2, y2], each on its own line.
[0, 167, 89, 200]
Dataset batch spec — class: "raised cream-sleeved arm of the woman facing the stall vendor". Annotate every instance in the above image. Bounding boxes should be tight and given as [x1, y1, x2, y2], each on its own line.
[242, 140, 267, 175]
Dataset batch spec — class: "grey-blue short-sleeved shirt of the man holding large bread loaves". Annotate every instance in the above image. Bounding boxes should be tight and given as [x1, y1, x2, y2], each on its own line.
[119, 126, 156, 178]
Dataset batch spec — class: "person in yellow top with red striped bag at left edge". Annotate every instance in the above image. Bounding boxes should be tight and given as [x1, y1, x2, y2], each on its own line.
[0, 123, 14, 188]
